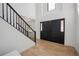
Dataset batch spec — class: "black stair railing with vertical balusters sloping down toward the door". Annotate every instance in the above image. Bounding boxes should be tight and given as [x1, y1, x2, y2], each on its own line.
[0, 3, 36, 42]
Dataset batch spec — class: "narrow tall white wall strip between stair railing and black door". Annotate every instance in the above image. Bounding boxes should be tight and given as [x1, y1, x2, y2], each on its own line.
[35, 3, 43, 41]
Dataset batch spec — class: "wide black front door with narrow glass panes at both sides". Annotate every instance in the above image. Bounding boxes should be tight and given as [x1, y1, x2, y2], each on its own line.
[41, 19, 64, 44]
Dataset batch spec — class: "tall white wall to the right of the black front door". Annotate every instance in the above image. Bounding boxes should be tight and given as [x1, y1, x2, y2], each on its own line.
[63, 3, 77, 47]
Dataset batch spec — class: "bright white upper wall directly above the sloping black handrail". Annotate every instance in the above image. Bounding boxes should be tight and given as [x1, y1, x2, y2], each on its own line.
[10, 3, 36, 19]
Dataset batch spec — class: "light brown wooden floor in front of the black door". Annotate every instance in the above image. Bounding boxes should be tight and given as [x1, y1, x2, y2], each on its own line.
[21, 40, 77, 56]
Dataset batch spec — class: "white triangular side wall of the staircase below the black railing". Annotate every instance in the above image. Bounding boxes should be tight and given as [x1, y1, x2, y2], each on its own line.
[0, 18, 35, 55]
